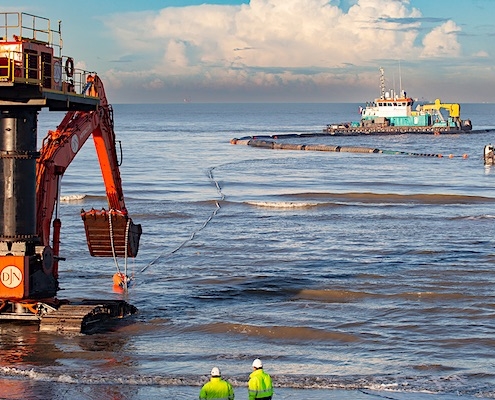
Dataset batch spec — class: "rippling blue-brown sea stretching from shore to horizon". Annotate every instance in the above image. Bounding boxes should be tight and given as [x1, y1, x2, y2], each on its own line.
[0, 102, 495, 400]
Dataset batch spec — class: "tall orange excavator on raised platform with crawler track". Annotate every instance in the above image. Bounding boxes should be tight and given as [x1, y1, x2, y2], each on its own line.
[0, 12, 142, 333]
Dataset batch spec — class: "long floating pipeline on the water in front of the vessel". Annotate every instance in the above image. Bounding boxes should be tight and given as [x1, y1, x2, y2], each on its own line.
[230, 136, 468, 158]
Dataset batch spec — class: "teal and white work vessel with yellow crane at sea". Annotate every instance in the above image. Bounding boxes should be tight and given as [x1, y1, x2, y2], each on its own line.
[323, 68, 472, 135]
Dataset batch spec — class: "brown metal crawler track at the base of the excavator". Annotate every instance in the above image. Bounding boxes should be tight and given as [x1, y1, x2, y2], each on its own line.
[39, 300, 137, 334]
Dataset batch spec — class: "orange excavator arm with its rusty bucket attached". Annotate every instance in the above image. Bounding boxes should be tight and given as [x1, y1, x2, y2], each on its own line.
[36, 75, 142, 276]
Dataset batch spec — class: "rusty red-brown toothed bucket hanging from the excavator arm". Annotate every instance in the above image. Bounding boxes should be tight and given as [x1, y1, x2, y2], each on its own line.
[81, 209, 142, 257]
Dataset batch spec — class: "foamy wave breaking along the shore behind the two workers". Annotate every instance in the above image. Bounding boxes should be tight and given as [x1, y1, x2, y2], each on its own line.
[0, 367, 495, 399]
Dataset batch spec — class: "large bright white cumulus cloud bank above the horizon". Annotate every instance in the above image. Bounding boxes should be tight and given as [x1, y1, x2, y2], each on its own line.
[100, 0, 468, 100]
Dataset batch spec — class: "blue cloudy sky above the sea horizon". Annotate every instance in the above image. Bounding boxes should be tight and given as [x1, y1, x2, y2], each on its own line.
[0, 0, 495, 103]
